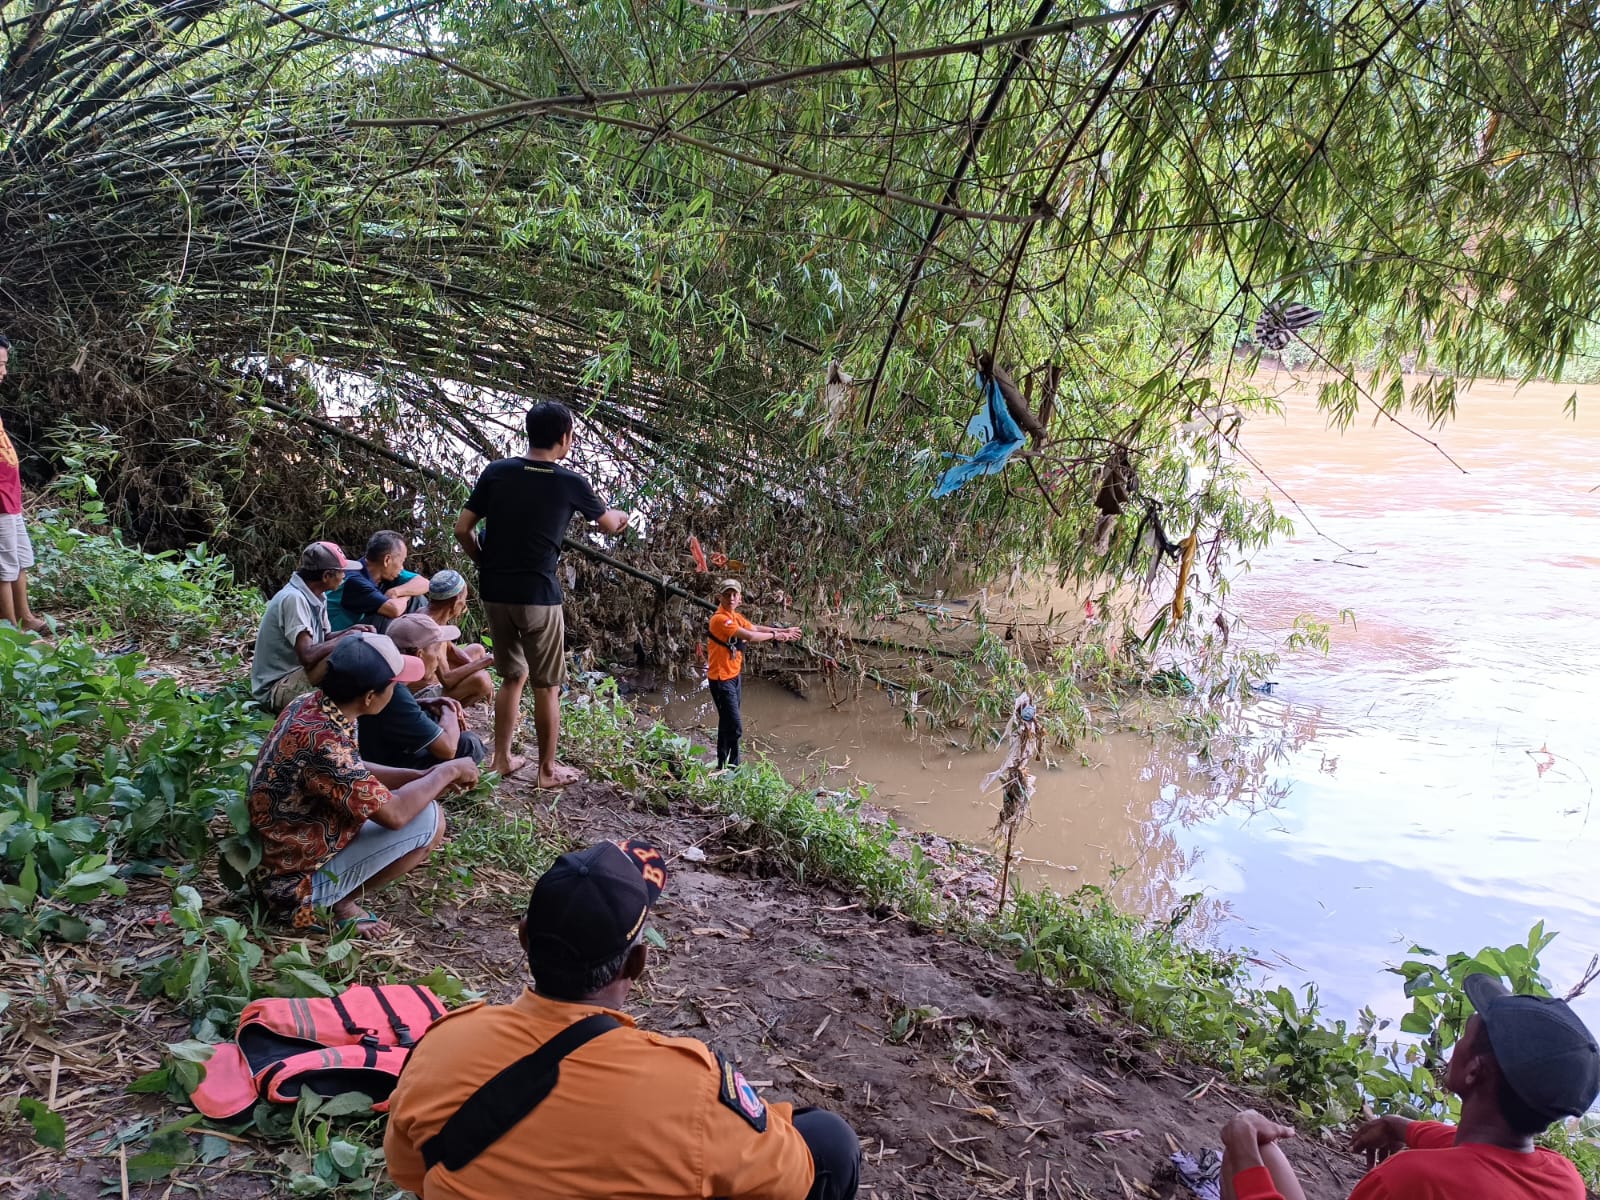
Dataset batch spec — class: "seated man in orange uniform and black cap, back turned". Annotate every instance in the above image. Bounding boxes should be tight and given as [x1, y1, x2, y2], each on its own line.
[384, 840, 861, 1200]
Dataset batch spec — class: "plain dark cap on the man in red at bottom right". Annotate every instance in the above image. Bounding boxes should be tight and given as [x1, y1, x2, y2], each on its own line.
[1461, 974, 1600, 1122]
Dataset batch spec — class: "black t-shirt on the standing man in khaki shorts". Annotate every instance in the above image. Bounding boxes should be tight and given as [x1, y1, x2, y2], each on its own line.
[467, 458, 605, 605]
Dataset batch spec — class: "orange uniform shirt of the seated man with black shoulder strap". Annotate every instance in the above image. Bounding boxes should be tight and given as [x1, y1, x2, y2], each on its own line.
[384, 989, 814, 1200]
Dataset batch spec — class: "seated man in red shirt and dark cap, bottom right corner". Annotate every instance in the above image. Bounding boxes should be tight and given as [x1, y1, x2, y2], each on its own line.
[1222, 974, 1600, 1200]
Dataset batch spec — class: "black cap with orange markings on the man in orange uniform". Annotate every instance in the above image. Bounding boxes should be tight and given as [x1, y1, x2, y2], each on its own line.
[525, 838, 667, 979]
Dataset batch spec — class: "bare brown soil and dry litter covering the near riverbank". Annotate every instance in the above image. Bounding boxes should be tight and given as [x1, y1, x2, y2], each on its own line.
[0, 781, 1357, 1200]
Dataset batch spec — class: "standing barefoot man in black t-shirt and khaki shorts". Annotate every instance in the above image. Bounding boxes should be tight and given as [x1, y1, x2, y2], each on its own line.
[456, 400, 627, 787]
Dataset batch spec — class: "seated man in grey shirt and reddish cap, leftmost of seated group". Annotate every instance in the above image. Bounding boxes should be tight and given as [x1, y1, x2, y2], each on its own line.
[250, 542, 373, 712]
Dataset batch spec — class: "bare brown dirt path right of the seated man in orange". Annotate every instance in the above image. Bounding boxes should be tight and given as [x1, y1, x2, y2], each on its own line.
[480, 786, 1357, 1200]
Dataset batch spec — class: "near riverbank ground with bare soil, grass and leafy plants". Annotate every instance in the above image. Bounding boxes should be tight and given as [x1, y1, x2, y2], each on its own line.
[0, 512, 1594, 1200]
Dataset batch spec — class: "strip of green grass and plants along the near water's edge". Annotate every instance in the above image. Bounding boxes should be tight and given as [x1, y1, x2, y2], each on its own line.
[566, 682, 1600, 1184]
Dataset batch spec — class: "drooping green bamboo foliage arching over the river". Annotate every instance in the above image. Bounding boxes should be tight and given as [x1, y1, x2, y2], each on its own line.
[0, 0, 1600, 640]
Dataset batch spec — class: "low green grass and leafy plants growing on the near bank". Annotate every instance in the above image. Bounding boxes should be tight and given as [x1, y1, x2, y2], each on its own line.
[0, 508, 1600, 1195]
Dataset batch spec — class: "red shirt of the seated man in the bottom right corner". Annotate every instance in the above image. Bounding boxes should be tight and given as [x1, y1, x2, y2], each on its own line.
[1234, 1122, 1587, 1200]
